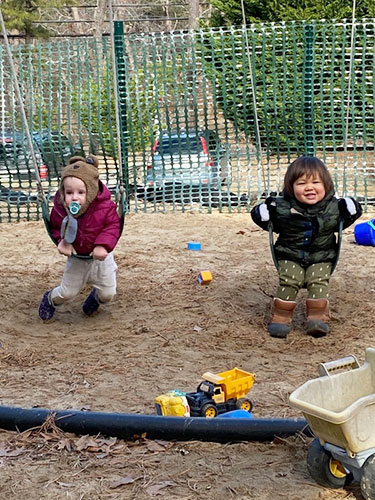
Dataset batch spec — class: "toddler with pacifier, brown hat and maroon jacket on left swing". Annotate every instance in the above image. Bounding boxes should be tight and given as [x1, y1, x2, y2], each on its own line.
[39, 156, 121, 321]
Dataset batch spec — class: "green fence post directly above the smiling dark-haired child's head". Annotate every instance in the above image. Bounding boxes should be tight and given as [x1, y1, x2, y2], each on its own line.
[302, 24, 315, 156]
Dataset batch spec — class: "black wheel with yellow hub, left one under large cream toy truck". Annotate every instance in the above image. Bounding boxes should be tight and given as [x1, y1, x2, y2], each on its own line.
[307, 438, 352, 486]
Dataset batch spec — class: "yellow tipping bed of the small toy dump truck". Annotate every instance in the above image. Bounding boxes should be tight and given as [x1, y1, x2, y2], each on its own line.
[202, 368, 255, 399]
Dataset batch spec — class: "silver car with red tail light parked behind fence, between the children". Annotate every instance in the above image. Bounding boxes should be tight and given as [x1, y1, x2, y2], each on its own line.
[146, 129, 231, 187]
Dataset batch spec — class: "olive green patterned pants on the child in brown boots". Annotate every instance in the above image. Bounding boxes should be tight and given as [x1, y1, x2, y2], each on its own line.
[276, 260, 332, 300]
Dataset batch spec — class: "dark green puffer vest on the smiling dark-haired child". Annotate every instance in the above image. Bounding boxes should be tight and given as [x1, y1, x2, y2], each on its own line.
[272, 193, 340, 267]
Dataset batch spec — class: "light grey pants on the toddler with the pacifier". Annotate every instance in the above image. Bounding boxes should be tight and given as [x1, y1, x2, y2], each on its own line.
[51, 252, 117, 306]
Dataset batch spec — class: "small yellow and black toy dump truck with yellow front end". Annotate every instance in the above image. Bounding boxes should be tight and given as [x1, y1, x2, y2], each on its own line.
[155, 368, 255, 418]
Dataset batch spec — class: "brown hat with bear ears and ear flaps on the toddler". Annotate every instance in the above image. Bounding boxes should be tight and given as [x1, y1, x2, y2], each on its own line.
[60, 156, 99, 216]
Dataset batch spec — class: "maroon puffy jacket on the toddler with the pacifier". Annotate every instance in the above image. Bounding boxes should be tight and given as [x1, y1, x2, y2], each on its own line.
[50, 181, 121, 255]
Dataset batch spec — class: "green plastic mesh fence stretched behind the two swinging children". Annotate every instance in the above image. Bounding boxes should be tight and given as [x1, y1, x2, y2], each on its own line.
[0, 19, 375, 221]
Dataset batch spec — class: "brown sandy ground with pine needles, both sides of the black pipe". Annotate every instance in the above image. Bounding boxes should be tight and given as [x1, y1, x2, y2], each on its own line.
[0, 209, 375, 500]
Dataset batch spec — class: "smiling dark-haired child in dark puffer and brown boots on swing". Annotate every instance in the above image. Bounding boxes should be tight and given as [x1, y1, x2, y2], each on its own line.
[251, 156, 362, 338]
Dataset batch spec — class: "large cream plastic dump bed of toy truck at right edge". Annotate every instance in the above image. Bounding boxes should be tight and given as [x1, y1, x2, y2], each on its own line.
[289, 348, 375, 453]
